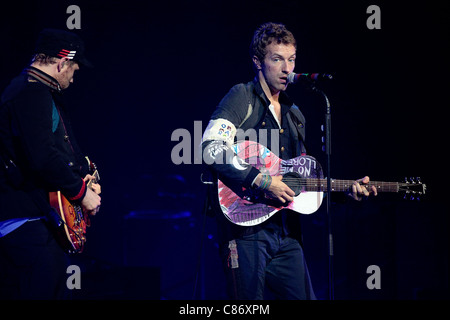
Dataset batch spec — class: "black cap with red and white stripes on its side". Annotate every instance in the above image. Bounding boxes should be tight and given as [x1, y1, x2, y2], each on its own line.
[34, 29, 92, 67]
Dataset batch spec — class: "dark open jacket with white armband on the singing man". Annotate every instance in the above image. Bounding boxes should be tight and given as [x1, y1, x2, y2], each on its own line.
[202, 79, 306, 241]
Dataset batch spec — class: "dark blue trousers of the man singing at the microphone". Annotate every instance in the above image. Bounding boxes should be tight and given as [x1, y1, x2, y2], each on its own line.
[221, 229, 316, 300]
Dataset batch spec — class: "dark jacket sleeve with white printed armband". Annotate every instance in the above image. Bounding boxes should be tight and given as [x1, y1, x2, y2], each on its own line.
[201, 84, 259, 188]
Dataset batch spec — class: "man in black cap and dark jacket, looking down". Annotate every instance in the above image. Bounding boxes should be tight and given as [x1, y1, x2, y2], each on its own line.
[0, 29, 101, 300]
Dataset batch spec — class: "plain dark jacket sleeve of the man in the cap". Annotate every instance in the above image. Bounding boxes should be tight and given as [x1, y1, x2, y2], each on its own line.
[12, 84, 86, 200]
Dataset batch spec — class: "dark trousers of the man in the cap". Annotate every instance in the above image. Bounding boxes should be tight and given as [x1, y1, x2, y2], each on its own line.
[0, 220, 69, 300]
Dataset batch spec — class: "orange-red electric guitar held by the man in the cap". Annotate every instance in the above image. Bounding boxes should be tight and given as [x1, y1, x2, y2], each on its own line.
[49, 159, 100, 253]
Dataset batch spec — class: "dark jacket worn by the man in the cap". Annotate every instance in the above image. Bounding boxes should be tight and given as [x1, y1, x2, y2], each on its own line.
[0, 67, 89, 221]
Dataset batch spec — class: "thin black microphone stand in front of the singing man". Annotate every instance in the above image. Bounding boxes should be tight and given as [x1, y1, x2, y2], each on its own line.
[311, 82, 334, 300]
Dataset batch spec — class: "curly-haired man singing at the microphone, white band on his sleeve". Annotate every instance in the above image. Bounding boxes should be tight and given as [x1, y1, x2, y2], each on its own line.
[202, 23, 377, 300]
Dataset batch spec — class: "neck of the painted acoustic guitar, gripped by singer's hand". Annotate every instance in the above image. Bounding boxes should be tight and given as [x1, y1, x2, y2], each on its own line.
[304, 179, 400, 192]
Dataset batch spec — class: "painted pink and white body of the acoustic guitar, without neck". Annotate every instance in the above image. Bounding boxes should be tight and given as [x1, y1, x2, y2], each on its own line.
[218, 141, 323, 226]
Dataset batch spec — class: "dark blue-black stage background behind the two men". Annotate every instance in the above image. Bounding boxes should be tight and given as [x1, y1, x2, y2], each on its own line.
[0, 0, 450, 300]
